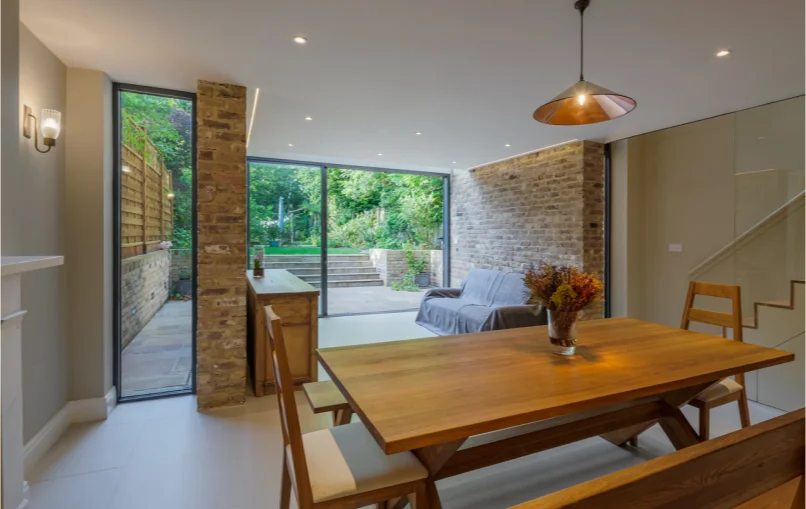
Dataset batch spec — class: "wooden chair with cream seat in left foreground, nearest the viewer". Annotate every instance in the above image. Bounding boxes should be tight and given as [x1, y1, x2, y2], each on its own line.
[265, 306, 428, 509]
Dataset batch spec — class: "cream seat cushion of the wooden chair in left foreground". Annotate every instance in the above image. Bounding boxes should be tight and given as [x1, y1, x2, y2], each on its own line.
[286, 422, 428, 502]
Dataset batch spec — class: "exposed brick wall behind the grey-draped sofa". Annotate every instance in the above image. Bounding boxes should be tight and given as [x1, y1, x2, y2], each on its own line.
[451, 141, 604, 316]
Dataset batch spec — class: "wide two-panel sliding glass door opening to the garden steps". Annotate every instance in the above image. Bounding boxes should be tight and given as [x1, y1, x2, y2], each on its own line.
[246, 159, 448, 315]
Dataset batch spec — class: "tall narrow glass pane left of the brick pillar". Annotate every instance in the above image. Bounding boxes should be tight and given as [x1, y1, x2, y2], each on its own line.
[117, 92, 194, 398]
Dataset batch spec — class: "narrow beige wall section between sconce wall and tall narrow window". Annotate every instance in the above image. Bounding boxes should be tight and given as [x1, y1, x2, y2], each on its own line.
[64, 68, 113, 399]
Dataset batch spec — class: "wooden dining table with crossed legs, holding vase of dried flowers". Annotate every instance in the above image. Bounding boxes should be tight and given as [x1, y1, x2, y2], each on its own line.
[317, 318, 794, 509]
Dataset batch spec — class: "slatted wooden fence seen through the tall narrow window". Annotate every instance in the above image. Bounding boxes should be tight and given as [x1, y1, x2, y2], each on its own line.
[120, 117, 173, 258]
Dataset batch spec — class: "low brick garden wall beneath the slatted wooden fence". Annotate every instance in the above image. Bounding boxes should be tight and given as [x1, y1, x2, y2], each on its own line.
[120, 251, 171, 347]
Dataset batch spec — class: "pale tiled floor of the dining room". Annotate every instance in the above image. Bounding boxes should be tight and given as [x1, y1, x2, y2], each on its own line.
[27, 313, 779, 509]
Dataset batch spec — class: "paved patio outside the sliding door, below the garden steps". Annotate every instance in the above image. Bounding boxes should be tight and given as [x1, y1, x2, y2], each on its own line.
[327, 286, 425, 315]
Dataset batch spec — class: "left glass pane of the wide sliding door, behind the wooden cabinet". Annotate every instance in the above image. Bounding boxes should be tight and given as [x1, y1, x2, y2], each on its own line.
[248, 161, 322, 313]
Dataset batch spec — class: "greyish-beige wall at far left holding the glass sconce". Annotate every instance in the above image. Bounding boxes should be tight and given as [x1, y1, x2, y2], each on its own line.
[17, 25, 69, 442]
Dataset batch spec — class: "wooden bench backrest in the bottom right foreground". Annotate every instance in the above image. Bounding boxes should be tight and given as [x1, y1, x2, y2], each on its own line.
[516, 409, 804, 509]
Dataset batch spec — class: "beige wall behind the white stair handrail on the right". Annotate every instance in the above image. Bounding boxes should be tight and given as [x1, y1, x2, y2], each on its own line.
[611, 97, 804, 325]
